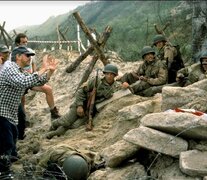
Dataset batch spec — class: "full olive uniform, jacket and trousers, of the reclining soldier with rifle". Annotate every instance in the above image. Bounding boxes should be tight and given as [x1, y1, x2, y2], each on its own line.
[46, 77, 121, 139]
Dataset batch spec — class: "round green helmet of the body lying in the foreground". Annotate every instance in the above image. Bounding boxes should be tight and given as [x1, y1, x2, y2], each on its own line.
[63, 154, 89, 180]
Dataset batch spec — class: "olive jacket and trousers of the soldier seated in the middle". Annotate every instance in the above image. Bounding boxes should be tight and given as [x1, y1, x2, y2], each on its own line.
[121, 59, 167, 96]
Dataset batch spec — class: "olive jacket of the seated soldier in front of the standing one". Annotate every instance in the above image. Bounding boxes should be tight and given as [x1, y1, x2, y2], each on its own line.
[137, 59, 168, 85]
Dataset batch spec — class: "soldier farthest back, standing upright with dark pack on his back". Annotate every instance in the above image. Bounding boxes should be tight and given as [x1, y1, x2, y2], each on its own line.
[153, 34, 184, 84]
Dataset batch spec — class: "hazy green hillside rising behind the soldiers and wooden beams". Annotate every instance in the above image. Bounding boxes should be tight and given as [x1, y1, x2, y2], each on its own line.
[12, 1, 192, 61]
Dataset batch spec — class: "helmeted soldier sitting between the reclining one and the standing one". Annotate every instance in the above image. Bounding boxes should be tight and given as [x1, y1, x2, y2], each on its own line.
[120, 46, 167, 96]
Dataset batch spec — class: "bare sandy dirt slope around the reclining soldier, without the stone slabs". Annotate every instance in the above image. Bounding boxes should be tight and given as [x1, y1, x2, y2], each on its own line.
[12, 50, 206, 180]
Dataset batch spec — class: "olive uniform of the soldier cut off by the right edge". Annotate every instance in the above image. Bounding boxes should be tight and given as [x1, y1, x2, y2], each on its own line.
[177, 63, 207, 86]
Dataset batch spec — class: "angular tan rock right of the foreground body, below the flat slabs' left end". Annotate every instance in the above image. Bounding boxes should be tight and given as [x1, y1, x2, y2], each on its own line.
[100, 140, 139, 168]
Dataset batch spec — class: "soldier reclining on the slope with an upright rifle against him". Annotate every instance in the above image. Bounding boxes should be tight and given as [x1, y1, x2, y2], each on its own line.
[46, 64, 121, 139]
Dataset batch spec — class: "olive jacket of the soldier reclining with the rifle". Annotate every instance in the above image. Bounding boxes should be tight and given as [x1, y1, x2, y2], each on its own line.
[74, 77, 121, 106]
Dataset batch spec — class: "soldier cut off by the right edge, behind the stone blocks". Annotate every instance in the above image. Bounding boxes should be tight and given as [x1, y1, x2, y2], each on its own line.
[176, 51, 207, 86]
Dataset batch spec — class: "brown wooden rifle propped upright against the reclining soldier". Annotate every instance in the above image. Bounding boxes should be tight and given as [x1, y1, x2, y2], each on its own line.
[86, 69, 99, 131]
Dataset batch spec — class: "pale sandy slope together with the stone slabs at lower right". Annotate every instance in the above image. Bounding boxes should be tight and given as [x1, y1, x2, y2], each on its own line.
[12, 50, 207, 180]
